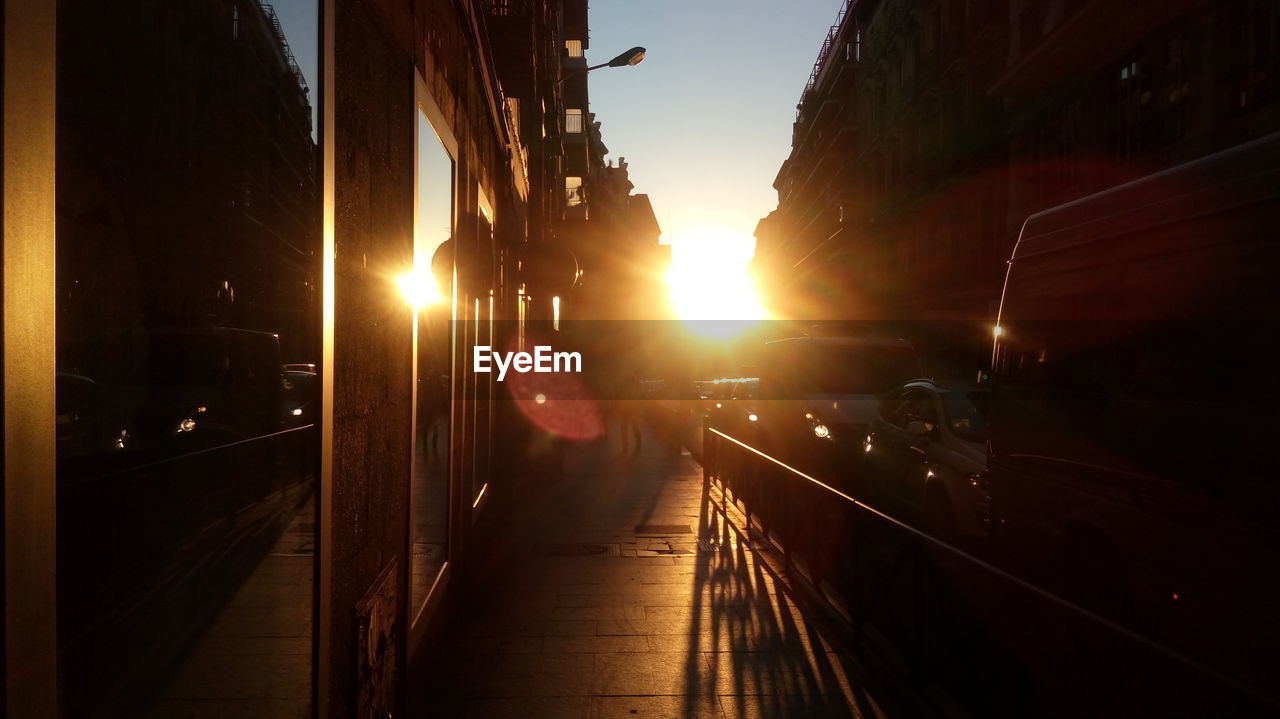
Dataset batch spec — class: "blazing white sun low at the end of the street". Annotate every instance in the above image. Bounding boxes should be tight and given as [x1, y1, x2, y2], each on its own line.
[667, 232, 768, 335]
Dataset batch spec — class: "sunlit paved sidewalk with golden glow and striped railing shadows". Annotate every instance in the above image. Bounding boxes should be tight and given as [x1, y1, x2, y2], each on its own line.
[426, 424, 882, 719]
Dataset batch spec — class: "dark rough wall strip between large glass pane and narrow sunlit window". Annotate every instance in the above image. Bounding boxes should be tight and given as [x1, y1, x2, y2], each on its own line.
[330, 0, 413, 716]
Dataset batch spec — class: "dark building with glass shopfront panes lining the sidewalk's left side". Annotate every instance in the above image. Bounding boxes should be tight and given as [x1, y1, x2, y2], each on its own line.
[0, 0, 655, 718]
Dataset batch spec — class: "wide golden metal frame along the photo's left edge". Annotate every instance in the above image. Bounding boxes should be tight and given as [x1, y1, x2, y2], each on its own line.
[3, 0, 58, 716]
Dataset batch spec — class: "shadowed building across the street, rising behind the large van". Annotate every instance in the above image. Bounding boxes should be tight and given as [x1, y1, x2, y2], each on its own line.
[754, 0, 1280, 374]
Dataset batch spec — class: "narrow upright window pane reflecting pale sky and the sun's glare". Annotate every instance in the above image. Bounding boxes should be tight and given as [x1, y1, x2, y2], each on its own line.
[410, 106, 453, 614]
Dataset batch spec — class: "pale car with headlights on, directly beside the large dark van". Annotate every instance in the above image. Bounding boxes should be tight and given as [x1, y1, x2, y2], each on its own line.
[859, 379, 991, 542]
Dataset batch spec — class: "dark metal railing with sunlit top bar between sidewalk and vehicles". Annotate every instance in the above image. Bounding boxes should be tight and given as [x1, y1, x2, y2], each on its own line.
[701, 425, 1280, 716]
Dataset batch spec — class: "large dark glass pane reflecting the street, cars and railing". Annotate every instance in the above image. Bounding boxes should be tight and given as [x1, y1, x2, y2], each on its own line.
[55, 0, 320, 716]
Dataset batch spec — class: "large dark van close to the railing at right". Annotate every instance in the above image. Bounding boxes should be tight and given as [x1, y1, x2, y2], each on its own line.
[988, 134, 1280, 695]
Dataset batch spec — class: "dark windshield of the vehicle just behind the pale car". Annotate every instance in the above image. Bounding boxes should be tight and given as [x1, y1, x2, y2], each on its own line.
[797, 345, 920, 394]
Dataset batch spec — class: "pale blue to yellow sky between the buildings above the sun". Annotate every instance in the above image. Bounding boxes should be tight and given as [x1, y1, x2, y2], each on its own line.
[586, 0, 844, 262]
